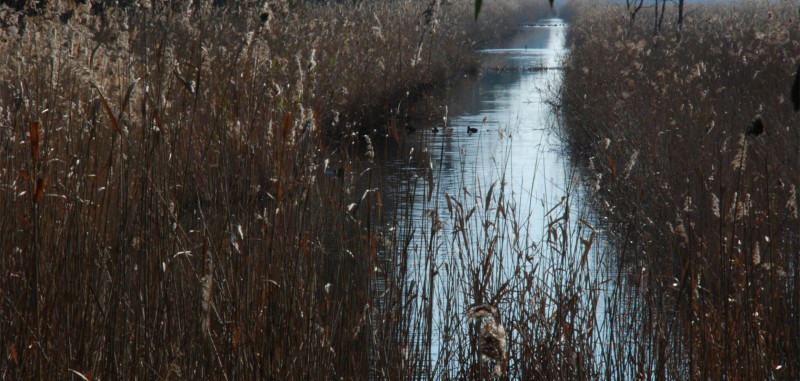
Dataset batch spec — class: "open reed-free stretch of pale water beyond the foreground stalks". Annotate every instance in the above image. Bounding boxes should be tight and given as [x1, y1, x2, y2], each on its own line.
[388, 19, 570, 252]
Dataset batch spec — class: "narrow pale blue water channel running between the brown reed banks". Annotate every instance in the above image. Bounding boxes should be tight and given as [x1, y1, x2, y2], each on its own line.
[376, 18, 608, 374]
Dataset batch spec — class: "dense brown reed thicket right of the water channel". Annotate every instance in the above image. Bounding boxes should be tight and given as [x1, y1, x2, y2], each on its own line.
[561, 1, 800, 380]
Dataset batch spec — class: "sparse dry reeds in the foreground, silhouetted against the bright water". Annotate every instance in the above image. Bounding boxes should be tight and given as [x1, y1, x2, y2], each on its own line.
[376, 120, 608, 380]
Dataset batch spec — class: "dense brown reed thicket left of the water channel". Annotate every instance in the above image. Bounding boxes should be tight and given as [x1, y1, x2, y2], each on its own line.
[0, 1, 556, 380]
